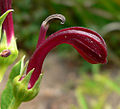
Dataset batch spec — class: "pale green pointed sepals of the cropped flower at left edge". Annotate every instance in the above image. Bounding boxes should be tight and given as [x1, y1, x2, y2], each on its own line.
[0, 9, 18, 82]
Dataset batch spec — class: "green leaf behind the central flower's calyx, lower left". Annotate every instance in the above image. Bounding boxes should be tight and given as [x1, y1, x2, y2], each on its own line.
[1, 57, 24, 109]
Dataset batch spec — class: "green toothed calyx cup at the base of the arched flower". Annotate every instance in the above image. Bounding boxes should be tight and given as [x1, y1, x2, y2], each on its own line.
[13, 69, 43, 102]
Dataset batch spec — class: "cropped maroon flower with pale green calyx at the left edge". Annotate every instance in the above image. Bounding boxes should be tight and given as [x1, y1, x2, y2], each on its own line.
[0, 0, 18, 81]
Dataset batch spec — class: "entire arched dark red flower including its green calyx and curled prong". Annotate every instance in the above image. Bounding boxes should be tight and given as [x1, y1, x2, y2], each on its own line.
[13, 14, 107, 101]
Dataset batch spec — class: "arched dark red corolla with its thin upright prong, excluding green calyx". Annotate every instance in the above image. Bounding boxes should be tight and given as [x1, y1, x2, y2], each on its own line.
[27, 14, 107, 88]
